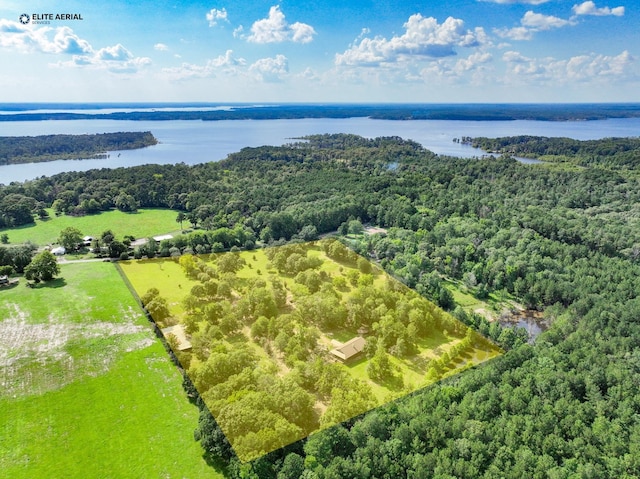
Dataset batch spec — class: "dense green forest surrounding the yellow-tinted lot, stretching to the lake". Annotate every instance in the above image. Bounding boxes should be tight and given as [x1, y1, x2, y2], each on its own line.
[0, 135, 640, 479]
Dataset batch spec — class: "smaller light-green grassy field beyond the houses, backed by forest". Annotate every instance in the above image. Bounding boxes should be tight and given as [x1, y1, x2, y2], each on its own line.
[0, 209, 179, 246]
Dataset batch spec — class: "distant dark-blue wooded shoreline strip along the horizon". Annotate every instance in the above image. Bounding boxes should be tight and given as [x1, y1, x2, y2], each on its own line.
[0, 103, 640, 122]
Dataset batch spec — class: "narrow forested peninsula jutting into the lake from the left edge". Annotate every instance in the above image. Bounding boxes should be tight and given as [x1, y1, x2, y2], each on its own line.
[0, 131, 158, 165]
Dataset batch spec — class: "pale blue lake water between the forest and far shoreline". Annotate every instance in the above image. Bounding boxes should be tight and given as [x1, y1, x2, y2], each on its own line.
[0, 118, 640, 184]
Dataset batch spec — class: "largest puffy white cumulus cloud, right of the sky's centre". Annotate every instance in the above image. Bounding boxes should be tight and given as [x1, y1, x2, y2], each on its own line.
[335, 13, 487, 65]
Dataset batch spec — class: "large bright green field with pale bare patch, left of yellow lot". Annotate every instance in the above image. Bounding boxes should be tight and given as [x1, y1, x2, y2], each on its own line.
[0, 263, 223, 479]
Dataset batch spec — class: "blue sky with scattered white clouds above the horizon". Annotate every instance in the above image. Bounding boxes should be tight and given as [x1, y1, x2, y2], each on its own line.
[0, 0, 640, 103]
